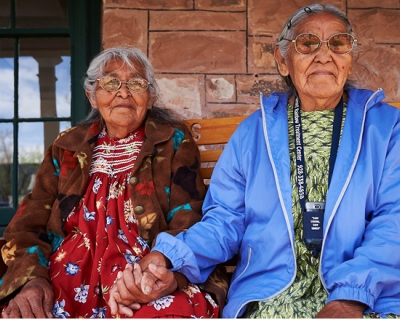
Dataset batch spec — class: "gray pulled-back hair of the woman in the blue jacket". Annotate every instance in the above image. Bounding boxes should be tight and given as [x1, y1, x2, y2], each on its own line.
[276, 3, 356, 91]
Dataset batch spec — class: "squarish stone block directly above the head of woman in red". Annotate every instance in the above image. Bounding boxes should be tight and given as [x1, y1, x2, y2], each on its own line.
[102, 9, 148, 53]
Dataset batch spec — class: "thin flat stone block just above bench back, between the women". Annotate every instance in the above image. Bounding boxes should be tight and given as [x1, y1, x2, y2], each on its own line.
[202, 103, 260, 118]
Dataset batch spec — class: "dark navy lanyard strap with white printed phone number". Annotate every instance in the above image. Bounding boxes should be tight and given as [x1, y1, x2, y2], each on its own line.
[293, 96, 343, 212]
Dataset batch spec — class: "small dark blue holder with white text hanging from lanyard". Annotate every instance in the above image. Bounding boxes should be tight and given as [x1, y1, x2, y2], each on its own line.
[303, 202, 325, 250]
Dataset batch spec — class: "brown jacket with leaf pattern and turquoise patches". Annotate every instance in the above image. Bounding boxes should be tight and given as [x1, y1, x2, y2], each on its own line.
[0, 118, 205, 302]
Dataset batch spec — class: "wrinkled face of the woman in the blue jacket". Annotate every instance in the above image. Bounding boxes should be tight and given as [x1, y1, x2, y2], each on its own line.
[275, 14, 353, 99]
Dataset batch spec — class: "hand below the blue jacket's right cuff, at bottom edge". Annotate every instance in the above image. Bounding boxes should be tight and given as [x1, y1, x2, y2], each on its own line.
[315, 300, 367, 318]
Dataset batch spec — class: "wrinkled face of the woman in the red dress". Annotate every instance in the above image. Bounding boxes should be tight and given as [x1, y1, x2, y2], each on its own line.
[86, 60, 153, 138]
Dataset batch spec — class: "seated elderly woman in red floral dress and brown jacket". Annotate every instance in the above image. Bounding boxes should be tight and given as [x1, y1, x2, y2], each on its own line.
[0, 47, 218, 318]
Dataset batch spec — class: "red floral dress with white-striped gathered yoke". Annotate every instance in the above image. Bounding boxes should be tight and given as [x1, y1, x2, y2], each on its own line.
[49, 127, 218, 318]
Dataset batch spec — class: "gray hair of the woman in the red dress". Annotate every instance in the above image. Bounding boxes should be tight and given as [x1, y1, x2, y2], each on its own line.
[80, 46, 173, 124]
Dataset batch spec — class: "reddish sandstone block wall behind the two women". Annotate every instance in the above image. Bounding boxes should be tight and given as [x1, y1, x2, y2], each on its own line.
[102, 0, 400, 118]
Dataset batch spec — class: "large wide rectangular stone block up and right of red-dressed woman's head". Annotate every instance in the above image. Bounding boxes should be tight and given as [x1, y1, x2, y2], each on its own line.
[149, 31, 246, 73]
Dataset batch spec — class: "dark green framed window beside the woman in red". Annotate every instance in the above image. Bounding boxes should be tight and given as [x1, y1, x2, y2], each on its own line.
[0, 0, 102, 236]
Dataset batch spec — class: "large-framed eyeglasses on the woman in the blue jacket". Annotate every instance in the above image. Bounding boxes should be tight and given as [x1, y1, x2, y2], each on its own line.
[282, 33, 357, 54]
